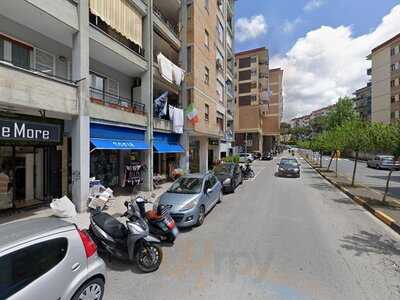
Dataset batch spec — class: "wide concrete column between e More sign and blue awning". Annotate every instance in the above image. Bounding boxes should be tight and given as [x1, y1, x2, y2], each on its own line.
[71, 0, 90, 212]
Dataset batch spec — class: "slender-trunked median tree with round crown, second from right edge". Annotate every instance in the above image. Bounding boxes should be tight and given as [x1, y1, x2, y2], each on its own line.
[337, 118, 374, 186]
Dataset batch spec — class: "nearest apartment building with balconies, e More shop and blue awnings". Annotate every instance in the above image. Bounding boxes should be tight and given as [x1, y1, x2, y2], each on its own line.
[0, 0, 191, 210]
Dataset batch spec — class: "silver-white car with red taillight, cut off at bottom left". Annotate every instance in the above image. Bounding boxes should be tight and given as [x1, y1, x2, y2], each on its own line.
[0, 218, 106, 300]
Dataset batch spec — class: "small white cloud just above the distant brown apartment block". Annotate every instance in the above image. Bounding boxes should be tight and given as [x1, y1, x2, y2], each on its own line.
[235, 15, 268, 42]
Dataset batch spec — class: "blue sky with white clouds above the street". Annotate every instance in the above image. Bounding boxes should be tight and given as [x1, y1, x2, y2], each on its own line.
[235, 0, 400, 120]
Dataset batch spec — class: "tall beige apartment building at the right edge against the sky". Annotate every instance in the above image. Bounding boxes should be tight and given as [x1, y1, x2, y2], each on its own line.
[368, 34, 400, 124]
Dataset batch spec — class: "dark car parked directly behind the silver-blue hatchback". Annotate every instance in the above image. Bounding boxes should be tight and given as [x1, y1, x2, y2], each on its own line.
[214, 163, 243, 193]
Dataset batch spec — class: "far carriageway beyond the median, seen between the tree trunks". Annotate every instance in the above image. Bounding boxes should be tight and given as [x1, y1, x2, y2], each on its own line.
[322, 156, 400, 198]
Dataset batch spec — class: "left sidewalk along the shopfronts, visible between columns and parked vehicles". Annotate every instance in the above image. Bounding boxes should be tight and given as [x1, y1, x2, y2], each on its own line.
[0, 182, 172, 228]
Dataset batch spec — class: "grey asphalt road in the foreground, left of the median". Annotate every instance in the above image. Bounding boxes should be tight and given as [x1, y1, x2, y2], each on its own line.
[105, 156, 400, 300]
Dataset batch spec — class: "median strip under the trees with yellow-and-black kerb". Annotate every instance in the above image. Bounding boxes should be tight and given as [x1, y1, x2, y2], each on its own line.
[303, 156, 400, 233]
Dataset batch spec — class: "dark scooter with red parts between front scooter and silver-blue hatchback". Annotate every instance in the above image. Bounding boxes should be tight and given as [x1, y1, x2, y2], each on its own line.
[134, 197, 179, 243]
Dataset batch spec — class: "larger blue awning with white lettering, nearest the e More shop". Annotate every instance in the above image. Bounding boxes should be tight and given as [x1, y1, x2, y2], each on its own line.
[90, 123, 150, 150]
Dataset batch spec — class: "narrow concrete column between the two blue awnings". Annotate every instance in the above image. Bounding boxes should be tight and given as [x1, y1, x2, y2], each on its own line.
[141, 0, 154, 191]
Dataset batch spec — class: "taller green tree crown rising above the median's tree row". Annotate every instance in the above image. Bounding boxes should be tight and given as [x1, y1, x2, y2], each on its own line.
[326, 97, 359, 129]
